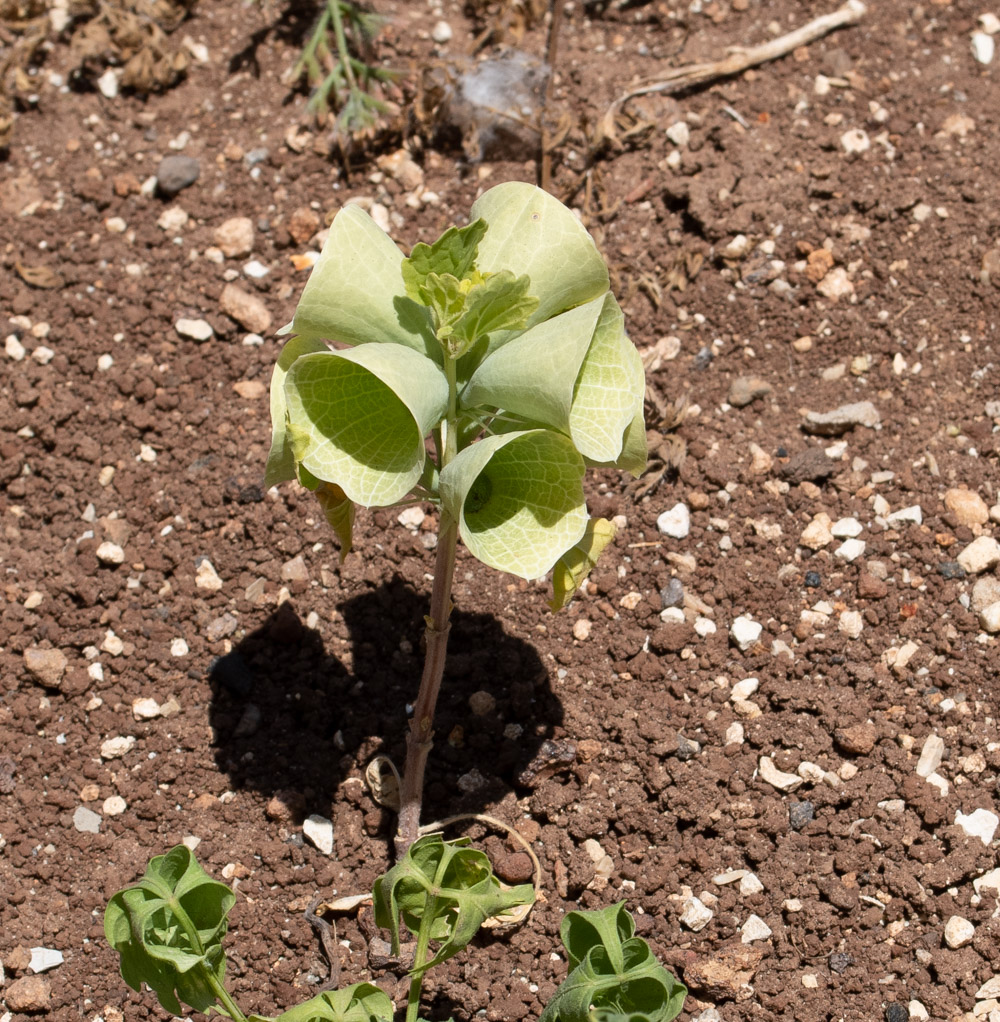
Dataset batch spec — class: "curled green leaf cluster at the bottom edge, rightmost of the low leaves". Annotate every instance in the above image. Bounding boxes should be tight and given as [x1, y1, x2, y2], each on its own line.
[539, 902, 687, 1022]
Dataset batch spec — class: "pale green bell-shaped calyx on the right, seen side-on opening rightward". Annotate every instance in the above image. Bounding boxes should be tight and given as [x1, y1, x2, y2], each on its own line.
[462, 292, 645, 470]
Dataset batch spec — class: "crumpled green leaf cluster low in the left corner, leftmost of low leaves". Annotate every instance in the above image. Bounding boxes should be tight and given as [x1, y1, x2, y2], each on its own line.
[104, 844, 236, 1015]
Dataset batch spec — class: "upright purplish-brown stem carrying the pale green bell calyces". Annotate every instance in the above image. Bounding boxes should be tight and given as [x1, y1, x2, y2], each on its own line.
[396, 358, 458, 860]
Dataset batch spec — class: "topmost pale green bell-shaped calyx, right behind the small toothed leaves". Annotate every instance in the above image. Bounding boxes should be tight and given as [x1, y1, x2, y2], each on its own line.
[470, 181, 608, 346]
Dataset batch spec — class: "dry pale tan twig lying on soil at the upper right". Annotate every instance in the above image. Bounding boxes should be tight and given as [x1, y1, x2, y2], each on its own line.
[600, 0, 866, 142]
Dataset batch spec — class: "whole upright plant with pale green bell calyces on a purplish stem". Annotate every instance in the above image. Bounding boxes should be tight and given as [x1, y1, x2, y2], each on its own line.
[266, 182, 646, 857]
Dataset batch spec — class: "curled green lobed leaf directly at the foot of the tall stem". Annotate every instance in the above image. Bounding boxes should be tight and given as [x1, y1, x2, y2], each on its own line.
[373, 834, 535, 976]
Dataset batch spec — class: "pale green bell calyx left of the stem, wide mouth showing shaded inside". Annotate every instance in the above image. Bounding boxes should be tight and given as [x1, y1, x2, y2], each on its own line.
[284, 344, 448, 507]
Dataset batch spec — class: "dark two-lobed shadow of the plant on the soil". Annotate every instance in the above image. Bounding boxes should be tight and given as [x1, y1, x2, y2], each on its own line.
[210, 576, 562, 826]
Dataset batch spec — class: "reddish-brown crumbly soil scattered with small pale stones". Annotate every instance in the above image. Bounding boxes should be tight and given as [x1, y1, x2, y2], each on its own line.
[0, 0, 1000, 1022]
